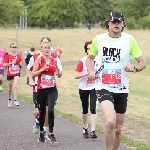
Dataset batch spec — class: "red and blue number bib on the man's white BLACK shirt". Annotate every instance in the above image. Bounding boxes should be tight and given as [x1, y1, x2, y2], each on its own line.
[102, 69, 121, 88]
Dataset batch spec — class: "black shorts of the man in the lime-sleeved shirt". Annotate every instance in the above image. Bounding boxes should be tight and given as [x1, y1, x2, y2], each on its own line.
[96, 89, 128, 114]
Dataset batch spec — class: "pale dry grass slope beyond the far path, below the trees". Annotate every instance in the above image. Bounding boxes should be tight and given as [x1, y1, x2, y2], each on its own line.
[0, 29, 150, 61]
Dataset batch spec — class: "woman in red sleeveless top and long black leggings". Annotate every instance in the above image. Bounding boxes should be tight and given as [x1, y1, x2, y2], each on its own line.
[32, 37, 60, 143]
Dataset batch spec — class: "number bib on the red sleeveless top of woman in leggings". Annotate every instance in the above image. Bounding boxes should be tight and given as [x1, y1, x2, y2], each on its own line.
[40, 74, 56, 88]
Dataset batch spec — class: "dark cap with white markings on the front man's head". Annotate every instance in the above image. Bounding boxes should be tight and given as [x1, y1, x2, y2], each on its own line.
[108, 11, 124, 22]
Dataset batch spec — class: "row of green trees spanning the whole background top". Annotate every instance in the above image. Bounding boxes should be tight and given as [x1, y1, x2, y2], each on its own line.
[0, 0, 150, 29]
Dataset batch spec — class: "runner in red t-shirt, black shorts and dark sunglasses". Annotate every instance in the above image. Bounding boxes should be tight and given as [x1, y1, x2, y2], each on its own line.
[3, 43, 22, 108]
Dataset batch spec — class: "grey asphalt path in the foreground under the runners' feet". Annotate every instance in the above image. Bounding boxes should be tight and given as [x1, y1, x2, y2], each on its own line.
[0, 63, 135, 150]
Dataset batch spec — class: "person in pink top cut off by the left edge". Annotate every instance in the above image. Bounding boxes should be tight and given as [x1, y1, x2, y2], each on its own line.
[0, 50, 6, 92]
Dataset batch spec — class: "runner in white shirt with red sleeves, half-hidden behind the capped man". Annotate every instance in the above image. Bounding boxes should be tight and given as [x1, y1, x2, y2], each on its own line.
[75, 41, 100, 139]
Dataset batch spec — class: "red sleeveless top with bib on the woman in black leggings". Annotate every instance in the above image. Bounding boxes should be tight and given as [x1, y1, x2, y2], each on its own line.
[37, 56, 57, 89]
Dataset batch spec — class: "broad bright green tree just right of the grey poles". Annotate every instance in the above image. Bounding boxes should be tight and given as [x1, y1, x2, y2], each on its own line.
[28, 0, 84, 29]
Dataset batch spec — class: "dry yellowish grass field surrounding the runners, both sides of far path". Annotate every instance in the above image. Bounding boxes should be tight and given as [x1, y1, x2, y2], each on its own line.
[0, 29, 150, 150]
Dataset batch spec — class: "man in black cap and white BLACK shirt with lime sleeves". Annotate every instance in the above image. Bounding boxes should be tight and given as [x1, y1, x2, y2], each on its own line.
[86, 11, 146, 150]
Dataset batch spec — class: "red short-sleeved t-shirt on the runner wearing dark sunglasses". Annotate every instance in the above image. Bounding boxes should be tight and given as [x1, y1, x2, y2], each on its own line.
[4, 54, 22, 76]
